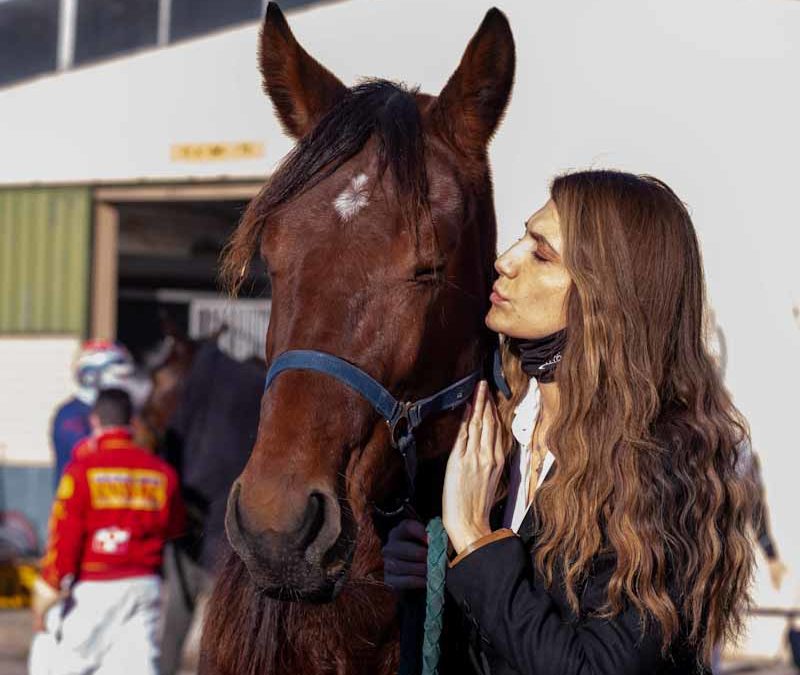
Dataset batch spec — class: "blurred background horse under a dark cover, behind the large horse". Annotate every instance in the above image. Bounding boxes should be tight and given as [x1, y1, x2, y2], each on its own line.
[141, 322, 266, 673]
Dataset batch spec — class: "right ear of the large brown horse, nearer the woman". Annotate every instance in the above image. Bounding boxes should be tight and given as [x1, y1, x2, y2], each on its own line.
[432, 7, 516, 156]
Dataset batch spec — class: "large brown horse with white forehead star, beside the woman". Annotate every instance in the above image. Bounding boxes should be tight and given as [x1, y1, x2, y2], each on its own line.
[202, 3, 515, 675]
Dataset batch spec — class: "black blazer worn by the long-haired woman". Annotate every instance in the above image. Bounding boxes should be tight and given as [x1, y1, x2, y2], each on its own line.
[446, 496, 711, 675]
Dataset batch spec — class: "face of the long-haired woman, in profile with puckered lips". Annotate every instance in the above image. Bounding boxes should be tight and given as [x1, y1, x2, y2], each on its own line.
[486, 201, 571, 340]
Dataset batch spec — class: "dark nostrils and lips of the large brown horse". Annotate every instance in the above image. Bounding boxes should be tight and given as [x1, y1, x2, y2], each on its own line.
[225, 481, 355, 602]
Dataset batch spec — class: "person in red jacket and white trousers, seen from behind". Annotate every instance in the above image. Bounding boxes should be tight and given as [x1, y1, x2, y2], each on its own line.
[29, 389, 184, 675]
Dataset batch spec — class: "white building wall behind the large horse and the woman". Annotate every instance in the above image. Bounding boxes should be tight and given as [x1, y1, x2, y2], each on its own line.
[0, 0, 800, 651]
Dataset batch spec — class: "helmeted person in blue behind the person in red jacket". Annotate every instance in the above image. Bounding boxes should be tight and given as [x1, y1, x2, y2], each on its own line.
[53, 340, 134, 485]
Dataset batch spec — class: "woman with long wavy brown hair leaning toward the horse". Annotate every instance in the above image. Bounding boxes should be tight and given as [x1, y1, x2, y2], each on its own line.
[385, 171, 753, 675]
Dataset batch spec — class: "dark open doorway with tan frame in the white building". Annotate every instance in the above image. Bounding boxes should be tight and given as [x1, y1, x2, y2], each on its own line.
[93, 188, 270, 360]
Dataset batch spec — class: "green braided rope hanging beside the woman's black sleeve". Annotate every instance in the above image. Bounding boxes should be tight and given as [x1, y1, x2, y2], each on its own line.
[422, 518, 447, 675]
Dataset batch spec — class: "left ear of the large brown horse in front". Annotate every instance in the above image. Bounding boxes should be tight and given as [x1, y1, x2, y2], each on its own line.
[260, 2, 347, 139]
